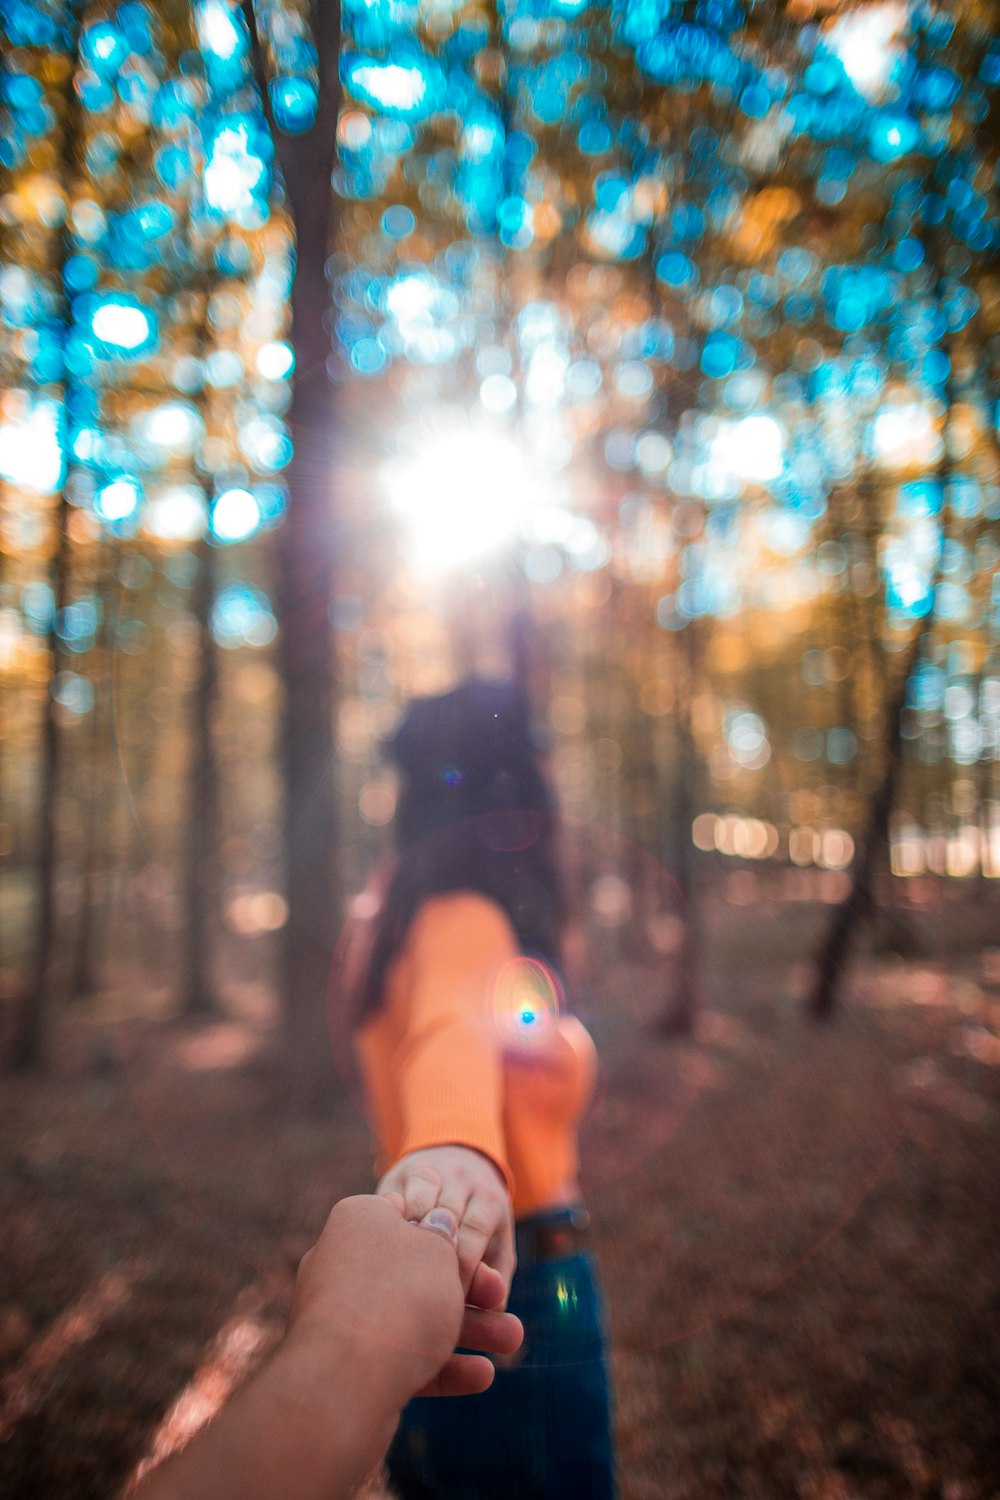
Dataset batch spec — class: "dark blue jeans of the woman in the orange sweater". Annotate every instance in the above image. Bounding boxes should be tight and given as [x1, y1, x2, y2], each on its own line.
[387, 1253, 616, 1500]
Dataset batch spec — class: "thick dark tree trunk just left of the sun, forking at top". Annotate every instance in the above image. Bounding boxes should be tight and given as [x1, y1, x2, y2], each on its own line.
[243, 0, 342, 1110]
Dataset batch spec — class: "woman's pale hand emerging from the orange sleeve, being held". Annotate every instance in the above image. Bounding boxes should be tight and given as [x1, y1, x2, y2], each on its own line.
[378, 1146, 516, 1308]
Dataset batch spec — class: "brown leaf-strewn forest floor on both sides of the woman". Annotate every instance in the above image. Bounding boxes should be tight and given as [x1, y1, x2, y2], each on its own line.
[0, 882, 1000, 1500]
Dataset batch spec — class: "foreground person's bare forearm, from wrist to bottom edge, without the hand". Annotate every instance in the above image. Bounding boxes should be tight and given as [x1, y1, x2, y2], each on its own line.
[130, 1337, 405, 1500]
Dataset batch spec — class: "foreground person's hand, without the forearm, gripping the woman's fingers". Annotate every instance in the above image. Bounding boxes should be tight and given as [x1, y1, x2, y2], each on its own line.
[288, 1196, 522, 1407]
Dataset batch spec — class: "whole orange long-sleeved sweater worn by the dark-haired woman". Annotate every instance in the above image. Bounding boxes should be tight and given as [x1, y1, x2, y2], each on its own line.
[355, 891, 595, 1217]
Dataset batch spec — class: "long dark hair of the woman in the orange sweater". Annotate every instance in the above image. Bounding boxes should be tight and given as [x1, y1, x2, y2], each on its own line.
[358, 678, 565, 1019]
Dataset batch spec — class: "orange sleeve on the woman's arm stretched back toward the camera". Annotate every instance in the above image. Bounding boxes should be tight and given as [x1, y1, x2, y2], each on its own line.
[393, 893, 517, 1191]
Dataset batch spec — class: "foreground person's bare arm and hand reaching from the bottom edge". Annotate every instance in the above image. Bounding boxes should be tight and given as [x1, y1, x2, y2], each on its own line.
[130, 1197, 522, 1500]
